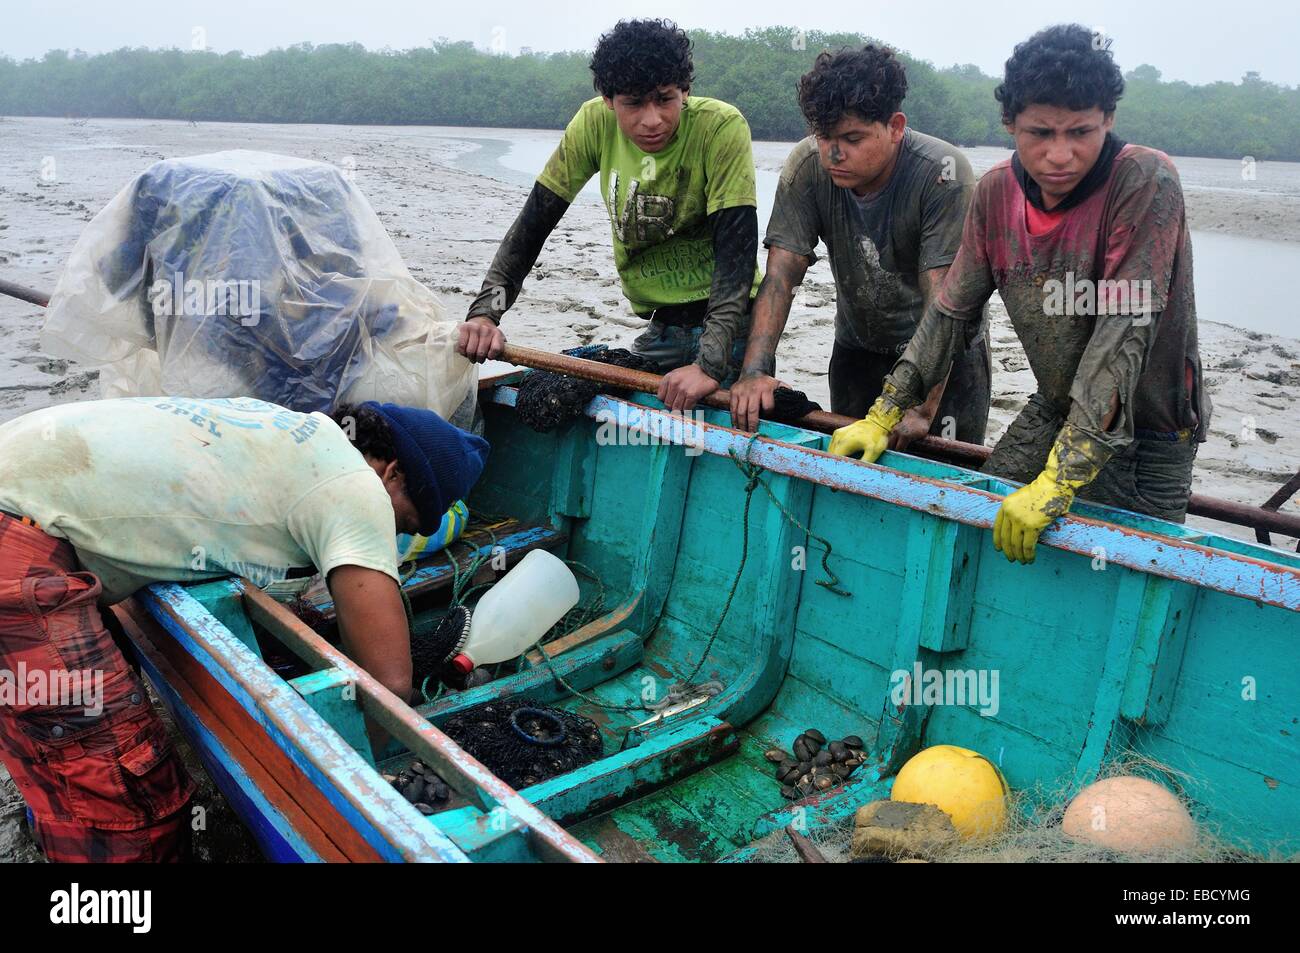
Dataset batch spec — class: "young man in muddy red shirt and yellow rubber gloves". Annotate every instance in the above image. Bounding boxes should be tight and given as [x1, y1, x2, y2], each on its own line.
[831, 25, 1210, 563]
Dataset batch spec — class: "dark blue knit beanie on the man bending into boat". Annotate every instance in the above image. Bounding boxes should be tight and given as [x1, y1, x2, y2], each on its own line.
[361, 400, 488, 536]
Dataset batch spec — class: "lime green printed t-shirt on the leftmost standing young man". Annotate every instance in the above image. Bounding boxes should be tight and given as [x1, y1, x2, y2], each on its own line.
[537, 96, 762, 315]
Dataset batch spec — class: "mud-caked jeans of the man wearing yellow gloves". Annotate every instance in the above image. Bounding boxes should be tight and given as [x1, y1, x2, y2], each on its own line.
[983, 394, 1197, 523]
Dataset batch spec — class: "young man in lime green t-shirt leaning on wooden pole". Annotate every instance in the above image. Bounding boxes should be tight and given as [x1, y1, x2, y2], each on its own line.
[458, 20, 761, 411]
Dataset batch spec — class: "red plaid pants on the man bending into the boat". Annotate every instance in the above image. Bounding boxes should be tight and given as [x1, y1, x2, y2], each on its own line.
[0, 514, 194, 862]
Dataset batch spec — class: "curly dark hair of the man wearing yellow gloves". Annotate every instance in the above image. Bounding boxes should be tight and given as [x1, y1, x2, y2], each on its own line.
[993, 23, 1125, 125]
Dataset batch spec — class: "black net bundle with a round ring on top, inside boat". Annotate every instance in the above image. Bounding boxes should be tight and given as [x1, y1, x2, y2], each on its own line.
[441, 698, 605, 789]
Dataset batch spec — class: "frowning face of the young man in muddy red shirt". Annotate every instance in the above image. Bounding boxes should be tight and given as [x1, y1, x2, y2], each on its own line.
[1006, 104, 1115, 208]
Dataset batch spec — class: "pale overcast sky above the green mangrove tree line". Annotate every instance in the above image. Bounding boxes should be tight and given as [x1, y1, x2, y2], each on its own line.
[10, 0, 1300, 86]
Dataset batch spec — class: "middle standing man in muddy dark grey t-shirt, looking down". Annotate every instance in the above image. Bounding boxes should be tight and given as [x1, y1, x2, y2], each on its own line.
[731, 46, 991, 450]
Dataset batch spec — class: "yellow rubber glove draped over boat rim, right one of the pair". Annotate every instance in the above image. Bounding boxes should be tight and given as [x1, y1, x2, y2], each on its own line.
[993, 424, 1112, 564]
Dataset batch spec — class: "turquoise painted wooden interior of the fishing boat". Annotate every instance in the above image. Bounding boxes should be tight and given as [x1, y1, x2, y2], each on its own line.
[126, 378, 1300, 861]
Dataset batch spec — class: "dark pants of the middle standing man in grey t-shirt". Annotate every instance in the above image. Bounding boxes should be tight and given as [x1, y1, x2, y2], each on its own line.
[829, 337, 993, 446]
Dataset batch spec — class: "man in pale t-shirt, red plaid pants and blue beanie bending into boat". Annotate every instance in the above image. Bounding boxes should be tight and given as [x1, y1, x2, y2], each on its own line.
[0, 398, 488, 861]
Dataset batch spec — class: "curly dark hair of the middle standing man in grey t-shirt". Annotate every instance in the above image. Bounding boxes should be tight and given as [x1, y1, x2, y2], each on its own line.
[800, 43, 907, 135]
